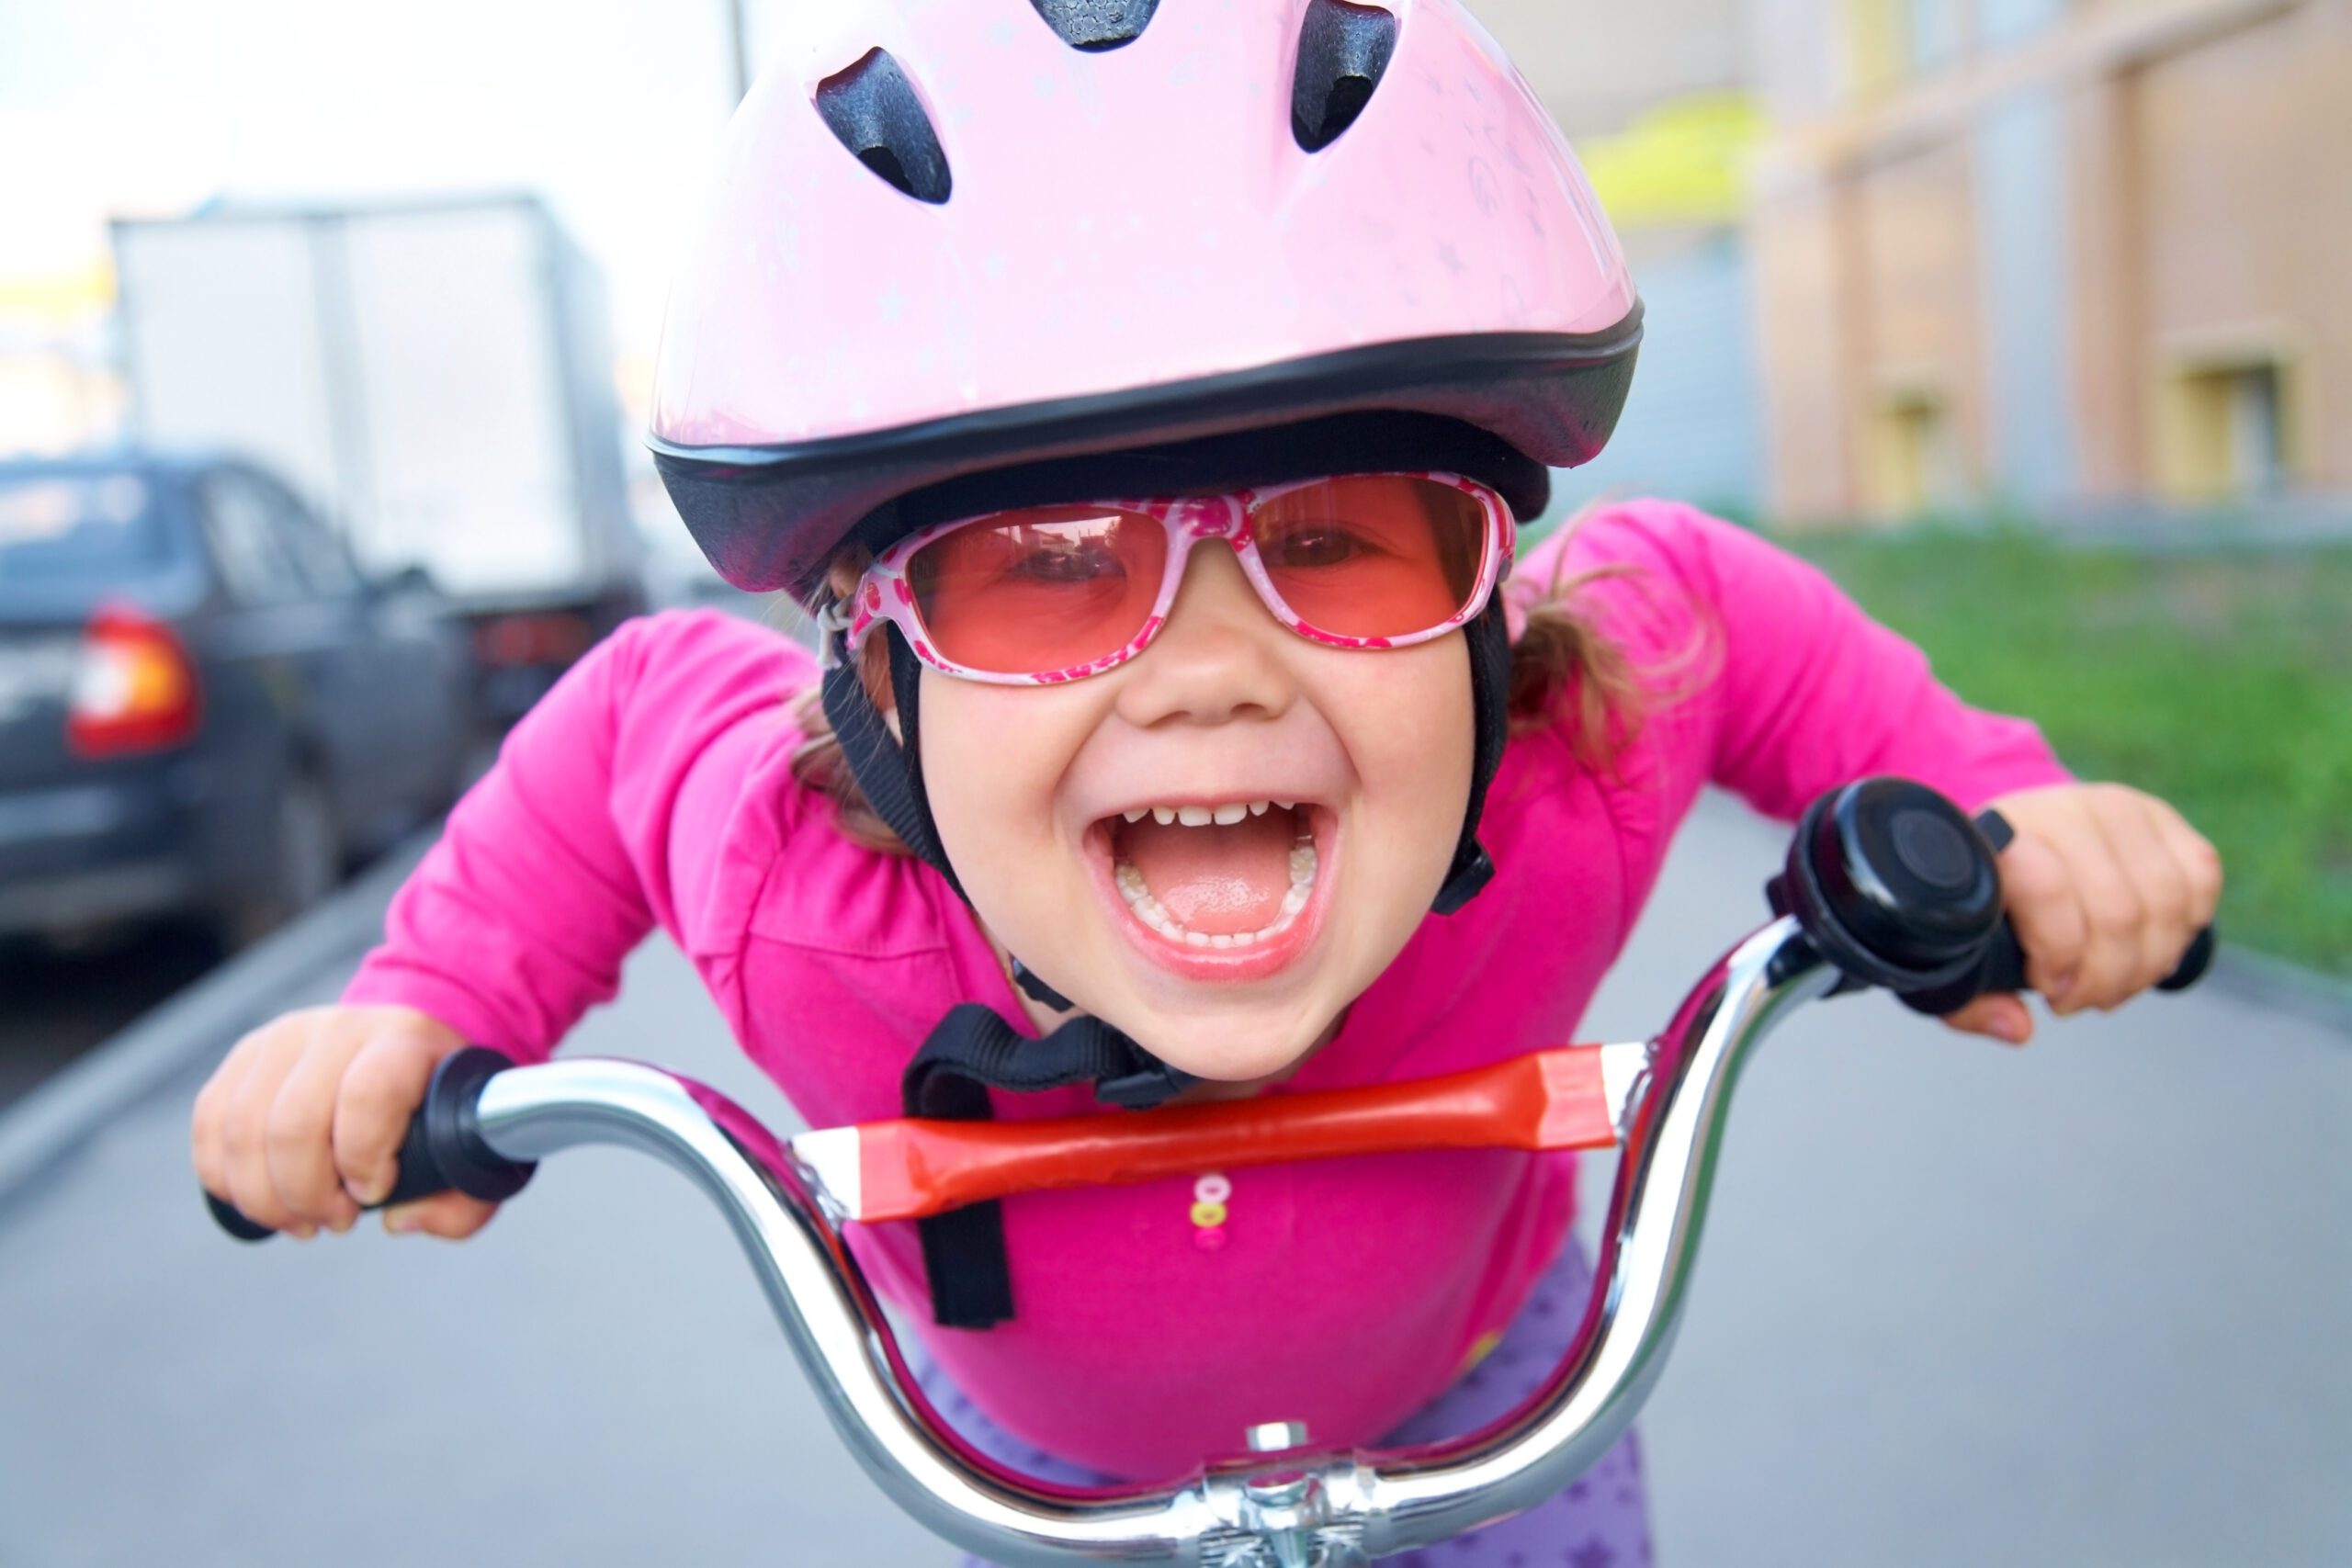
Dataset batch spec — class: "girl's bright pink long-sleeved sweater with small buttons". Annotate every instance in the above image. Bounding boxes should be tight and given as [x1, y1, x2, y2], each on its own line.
[345, 501, 2065, 1479]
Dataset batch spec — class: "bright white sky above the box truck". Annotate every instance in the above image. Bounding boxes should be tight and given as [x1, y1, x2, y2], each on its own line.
[0, 0, 780, 357]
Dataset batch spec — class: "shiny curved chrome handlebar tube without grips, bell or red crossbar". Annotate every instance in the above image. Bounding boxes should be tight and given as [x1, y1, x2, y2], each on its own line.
[463, 917, 1839, 1568]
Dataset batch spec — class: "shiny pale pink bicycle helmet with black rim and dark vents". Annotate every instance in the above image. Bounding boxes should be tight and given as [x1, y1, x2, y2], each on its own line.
[651, 0, 1642, 602]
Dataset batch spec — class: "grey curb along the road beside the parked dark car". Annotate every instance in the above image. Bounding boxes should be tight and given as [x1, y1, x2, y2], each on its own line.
[0, 823, 440, 1206]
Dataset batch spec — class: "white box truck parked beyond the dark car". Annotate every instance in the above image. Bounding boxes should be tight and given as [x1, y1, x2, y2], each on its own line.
[113, 195, 644, 719]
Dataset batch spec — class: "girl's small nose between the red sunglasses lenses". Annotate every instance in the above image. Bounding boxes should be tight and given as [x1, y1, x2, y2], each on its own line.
[1120, 538, 1296, 728]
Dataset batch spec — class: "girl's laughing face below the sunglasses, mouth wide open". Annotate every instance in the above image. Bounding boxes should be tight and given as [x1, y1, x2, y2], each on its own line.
[922, 543, 1473, 1079]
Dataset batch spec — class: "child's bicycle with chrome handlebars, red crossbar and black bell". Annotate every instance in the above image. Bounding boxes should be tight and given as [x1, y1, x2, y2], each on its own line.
[207, 778, 2213, 1568]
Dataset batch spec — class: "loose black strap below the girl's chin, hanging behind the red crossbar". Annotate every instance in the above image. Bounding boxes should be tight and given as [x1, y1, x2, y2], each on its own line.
[899, 1001, 1194, 1328]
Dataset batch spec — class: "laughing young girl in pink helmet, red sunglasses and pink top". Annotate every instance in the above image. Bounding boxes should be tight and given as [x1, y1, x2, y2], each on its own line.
[193, 0, 2221, 1568]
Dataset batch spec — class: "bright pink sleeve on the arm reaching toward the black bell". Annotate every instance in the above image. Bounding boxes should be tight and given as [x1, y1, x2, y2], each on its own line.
[1538, 501, 2070, 820]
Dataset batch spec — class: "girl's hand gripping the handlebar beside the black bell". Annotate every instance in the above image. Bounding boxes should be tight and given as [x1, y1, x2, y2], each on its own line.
[1945, 785, 2221, 1046]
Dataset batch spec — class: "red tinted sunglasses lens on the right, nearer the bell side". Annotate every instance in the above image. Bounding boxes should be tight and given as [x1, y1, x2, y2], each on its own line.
[1249, 475, 1487, 637]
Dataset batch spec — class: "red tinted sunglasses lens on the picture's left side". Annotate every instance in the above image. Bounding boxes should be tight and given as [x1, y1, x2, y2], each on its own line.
[906, 505, 1169, 674]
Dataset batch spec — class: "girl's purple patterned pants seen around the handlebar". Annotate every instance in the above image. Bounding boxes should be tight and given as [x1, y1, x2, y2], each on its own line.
[917, 1239, 1651, 1568]
